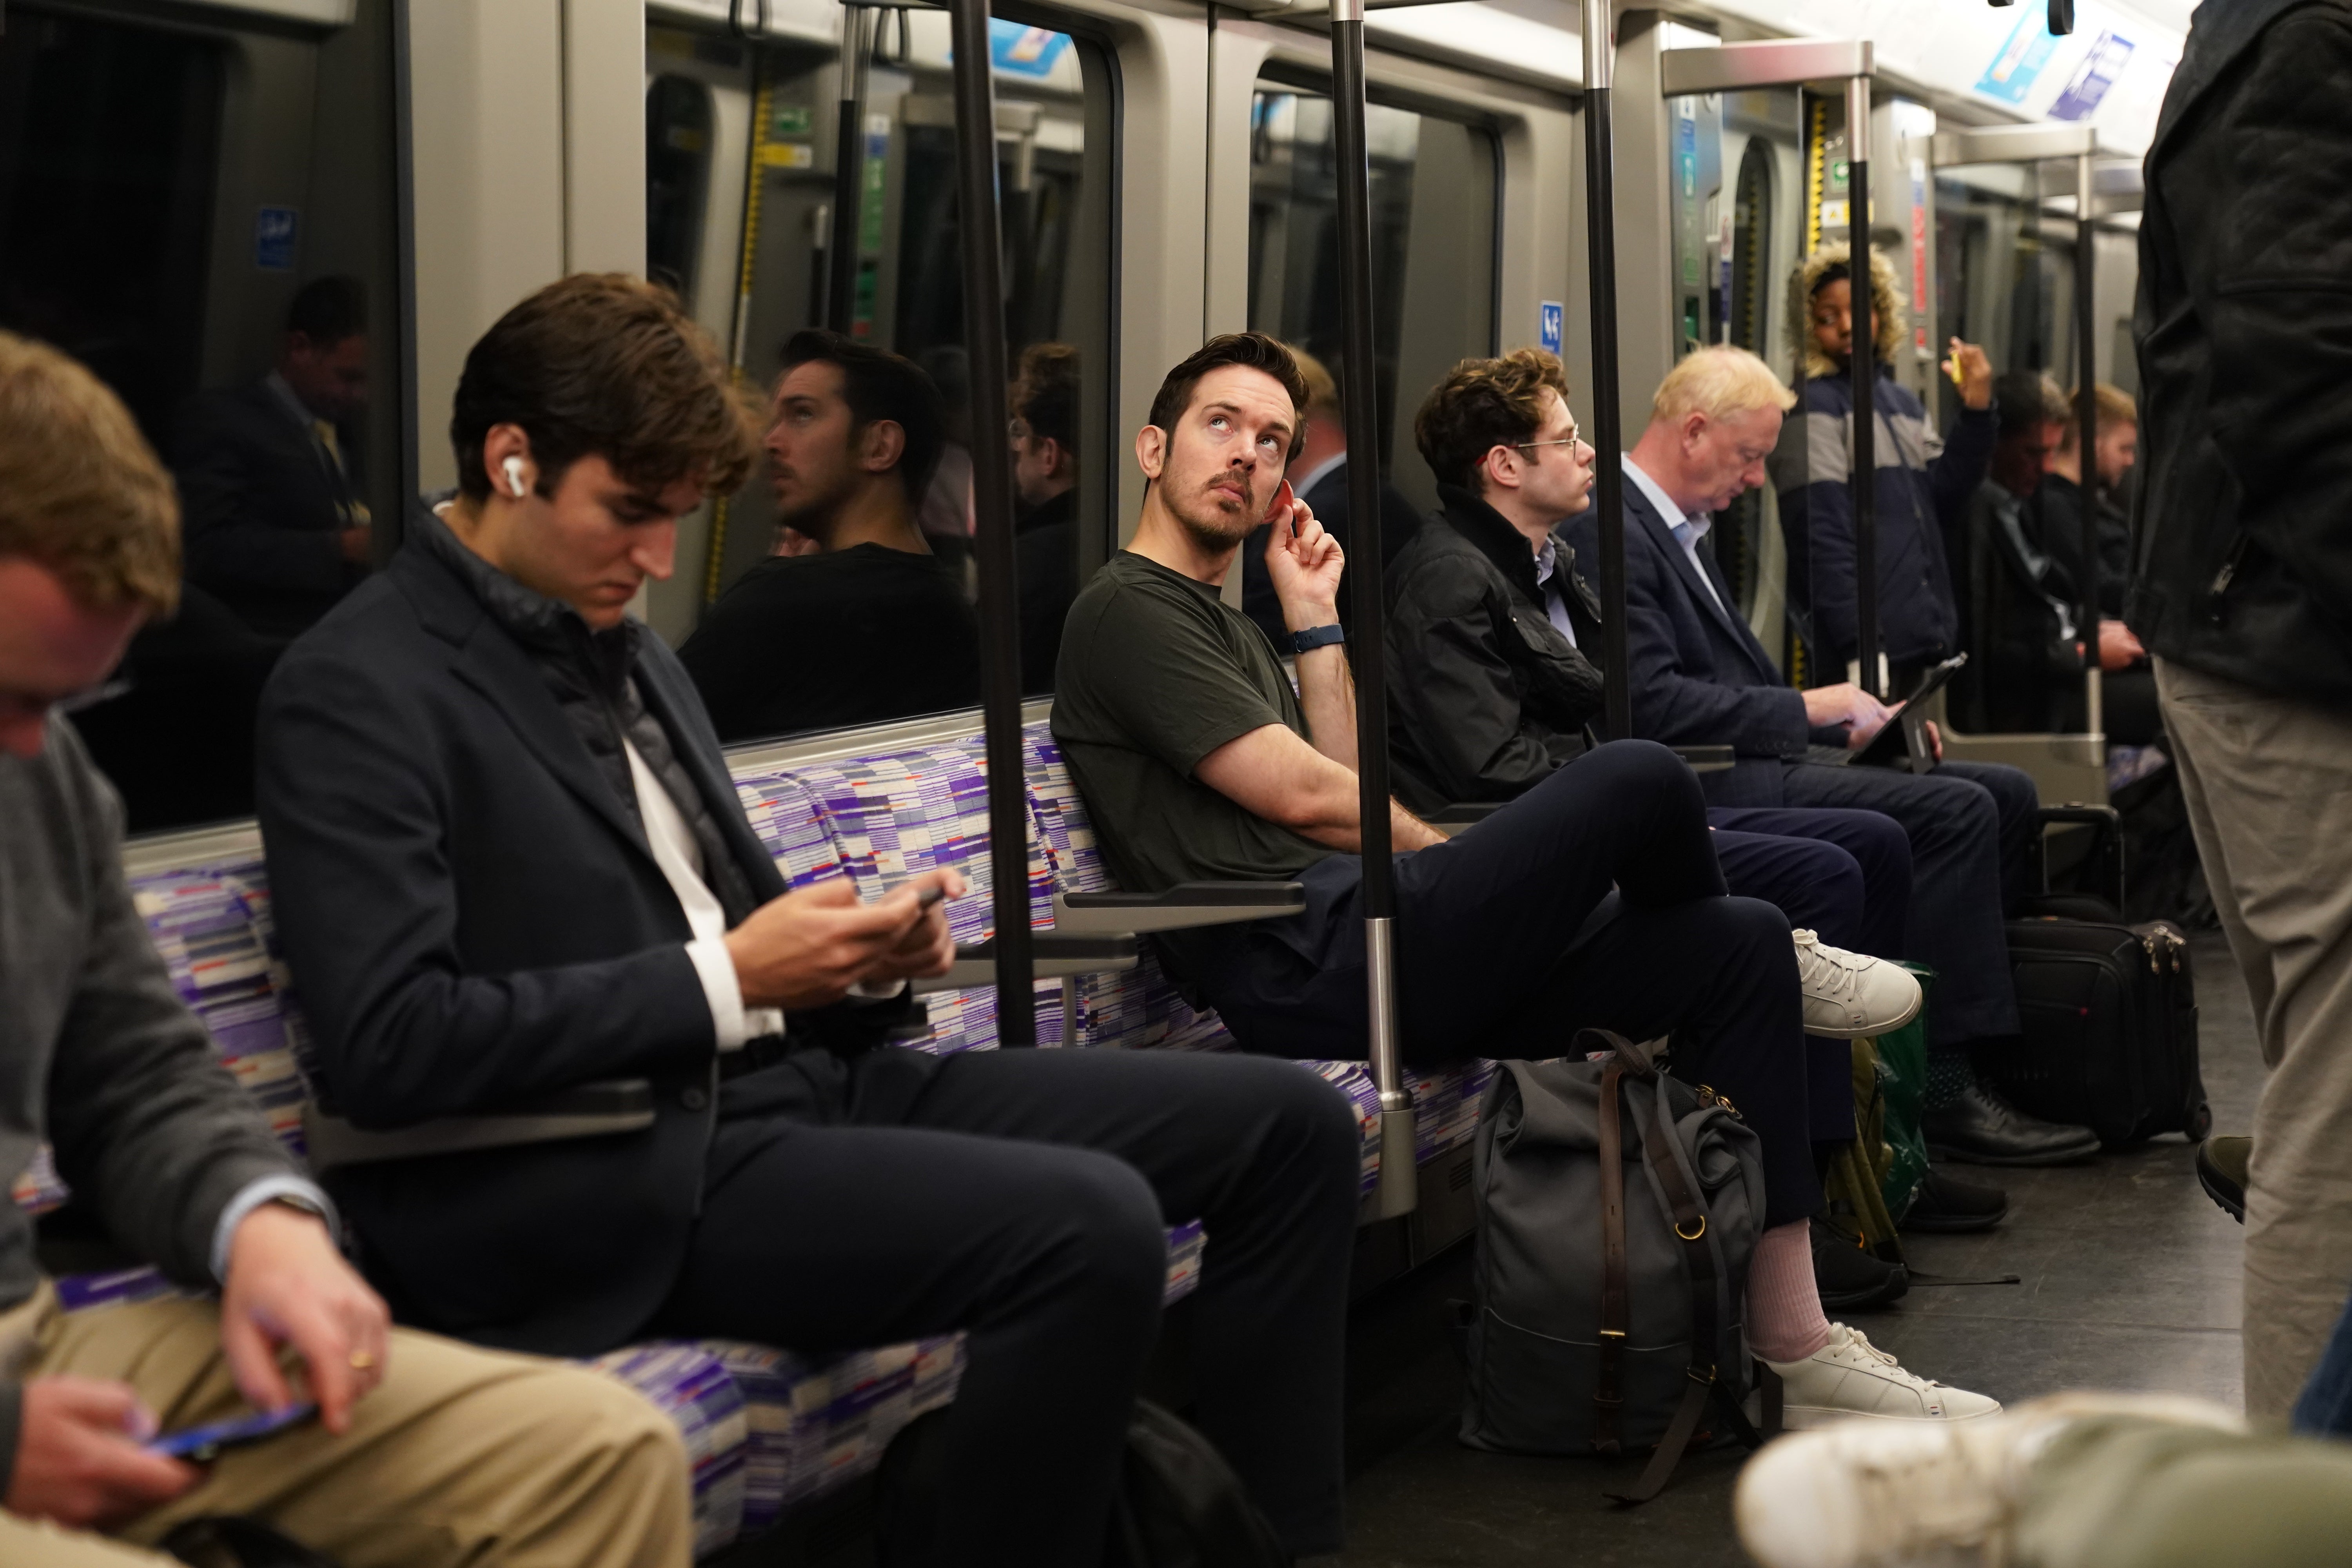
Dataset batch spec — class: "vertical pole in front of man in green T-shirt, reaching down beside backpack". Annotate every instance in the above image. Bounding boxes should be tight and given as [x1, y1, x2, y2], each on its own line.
[1331, 0, 1418, 1220]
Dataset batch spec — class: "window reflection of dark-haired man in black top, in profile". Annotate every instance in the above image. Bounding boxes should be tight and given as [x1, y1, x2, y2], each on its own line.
[677, 332, 981, 740]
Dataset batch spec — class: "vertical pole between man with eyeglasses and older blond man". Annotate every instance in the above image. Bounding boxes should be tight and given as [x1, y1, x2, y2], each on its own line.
[1583, 0, 1632, 740]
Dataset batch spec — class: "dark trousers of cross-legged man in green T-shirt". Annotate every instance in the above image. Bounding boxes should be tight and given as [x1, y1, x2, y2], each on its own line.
[1192, 740, 1820, 1225]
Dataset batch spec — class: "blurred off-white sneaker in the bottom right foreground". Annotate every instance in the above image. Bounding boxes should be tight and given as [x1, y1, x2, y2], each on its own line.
[1731, 1394, 2244, 1568]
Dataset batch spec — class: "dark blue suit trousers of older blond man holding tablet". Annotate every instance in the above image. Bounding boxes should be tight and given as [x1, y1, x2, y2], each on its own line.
[1783, 762, 2037, 1046]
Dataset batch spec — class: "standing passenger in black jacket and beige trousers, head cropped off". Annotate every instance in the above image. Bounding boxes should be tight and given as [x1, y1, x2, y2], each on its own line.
[2124, 0, 2352, 1422]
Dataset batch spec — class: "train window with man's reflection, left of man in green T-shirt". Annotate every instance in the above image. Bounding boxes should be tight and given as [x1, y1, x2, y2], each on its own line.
[647, 9, 1117, 740]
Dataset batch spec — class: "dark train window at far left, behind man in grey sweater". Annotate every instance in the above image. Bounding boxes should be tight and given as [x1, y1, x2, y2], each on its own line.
[0, 0, 402, 832]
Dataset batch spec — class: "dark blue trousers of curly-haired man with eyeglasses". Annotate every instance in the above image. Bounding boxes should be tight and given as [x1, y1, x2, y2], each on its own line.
[1708, 806, 1910, 1143]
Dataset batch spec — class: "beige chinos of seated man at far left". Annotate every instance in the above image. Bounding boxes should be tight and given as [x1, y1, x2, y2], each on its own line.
[0, 1283, 694, 1568]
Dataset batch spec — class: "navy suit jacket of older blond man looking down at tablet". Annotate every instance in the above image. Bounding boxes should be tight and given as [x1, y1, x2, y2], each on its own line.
[1566, 475, 1813, 806]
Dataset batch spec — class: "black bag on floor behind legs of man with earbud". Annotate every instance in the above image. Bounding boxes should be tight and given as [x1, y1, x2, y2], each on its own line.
[875, 1399, 1291, 1568]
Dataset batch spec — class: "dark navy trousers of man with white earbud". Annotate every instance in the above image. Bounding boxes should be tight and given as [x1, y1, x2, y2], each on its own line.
[652, 1049, 1364, 1568]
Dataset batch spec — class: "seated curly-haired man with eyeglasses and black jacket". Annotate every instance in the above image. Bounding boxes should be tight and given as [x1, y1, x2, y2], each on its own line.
[1385, 348, 1976, 1307]
